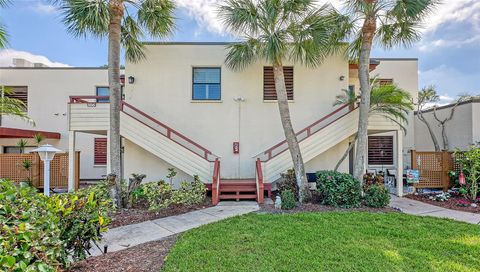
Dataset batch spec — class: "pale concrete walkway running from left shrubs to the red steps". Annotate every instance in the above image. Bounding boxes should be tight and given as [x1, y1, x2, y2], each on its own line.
[91, 201, 259, 256]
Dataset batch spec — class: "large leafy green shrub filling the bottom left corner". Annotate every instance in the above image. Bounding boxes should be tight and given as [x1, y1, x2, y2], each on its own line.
[0, 180, 111, 271]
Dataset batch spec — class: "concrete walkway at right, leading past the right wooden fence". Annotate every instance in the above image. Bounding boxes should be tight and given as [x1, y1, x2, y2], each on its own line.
[390, 195, 480, 224]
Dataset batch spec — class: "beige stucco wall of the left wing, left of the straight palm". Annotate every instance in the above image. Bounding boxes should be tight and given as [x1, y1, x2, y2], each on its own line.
[0, 68, 108, 179]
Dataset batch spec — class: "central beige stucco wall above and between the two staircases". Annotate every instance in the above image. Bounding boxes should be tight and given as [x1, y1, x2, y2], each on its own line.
[125, 45, 348, 179]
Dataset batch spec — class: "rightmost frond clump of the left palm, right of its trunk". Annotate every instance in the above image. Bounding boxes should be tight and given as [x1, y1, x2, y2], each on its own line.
[137, 0, 175, 38]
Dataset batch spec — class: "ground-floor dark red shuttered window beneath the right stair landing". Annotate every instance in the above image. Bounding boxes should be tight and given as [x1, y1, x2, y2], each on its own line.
[368, 136, 393, 165]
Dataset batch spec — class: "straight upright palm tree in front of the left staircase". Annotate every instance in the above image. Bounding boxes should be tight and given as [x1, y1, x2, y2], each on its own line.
[54, 0, 175, 207]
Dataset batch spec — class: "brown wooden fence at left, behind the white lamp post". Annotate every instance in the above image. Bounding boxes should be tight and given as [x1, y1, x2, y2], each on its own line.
[0, 151, 80, 190]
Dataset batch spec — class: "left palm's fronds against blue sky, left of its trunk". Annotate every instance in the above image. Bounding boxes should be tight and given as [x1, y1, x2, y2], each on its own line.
[55, 0, 110, 37]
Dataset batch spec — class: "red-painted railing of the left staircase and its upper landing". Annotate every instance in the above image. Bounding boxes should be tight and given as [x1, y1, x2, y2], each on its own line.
[70, 96, 218, 162]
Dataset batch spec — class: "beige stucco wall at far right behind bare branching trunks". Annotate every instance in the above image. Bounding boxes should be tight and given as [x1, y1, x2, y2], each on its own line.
[415, 101, 480, 151]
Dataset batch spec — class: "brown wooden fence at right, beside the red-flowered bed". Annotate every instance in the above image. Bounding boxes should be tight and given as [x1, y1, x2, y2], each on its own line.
[412, 150, 459, 191]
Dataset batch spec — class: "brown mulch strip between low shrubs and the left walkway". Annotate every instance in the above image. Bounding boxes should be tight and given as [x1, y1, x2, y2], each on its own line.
[108, 197, 212, 228]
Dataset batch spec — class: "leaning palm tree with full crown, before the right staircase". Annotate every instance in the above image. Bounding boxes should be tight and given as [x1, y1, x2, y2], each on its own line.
[220, 0, 345, 201]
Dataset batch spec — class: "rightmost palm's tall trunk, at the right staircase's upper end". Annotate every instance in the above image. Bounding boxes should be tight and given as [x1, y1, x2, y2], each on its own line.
[353, 15, 377, 183]
